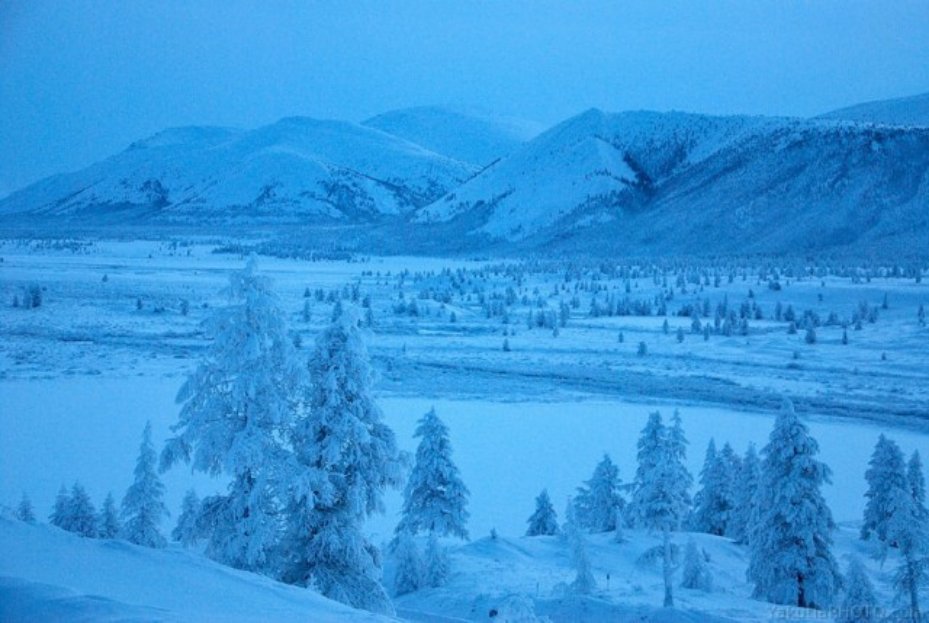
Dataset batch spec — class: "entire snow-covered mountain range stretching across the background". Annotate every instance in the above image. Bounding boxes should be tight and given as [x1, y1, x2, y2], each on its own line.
[0, 103, 929, 255]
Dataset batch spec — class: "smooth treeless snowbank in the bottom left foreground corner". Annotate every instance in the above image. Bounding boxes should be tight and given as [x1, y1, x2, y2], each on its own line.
[0, 517, 392, 623]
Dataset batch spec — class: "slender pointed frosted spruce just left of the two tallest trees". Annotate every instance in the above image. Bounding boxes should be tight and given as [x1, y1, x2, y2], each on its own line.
[122, 422, 168, 548]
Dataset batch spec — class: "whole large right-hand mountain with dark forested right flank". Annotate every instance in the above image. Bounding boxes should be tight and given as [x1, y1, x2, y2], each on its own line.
[415, 110, 929, 253]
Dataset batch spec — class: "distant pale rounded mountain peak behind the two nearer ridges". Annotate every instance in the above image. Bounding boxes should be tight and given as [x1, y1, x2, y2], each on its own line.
[362, 106, 544, 166]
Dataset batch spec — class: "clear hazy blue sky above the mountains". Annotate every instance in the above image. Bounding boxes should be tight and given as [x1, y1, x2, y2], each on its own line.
[0, 0, 929, 196]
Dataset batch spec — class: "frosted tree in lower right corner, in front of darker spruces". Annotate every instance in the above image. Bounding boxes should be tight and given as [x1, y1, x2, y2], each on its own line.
[885, 478, 929, 623]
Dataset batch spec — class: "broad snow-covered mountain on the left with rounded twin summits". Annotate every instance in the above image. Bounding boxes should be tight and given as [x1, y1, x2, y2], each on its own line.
[0, 117, 475, 224]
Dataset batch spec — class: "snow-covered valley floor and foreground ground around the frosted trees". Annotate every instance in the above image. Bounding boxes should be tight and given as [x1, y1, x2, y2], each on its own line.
[0, 236, 929, 621]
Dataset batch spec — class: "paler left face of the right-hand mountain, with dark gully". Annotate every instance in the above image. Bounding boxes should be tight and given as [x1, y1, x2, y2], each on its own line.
[417, 109, 774, 240]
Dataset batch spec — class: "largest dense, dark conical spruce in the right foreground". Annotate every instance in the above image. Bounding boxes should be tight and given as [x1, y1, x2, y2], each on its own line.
[746, 399, 841, 609]
